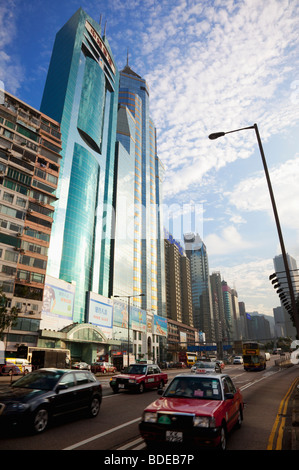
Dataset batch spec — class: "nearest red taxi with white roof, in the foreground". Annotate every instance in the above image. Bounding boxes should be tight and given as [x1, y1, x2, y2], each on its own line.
[139, 374, 244, 451]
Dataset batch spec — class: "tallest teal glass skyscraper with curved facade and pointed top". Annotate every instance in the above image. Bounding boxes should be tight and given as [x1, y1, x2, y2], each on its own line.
[41, 8, 119, 323]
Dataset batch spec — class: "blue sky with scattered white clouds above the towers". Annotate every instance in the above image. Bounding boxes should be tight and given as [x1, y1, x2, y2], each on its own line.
[0, 0, 299, 315]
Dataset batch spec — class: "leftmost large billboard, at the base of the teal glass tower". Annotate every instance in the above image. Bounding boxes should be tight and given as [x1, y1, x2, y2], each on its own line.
[40, 276, 76, 330]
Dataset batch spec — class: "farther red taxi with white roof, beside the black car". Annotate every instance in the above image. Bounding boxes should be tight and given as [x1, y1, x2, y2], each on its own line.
[110, 364, 168, 393]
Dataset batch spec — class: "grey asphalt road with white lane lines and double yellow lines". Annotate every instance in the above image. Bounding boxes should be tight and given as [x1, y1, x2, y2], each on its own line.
[0, 358, 299, 451]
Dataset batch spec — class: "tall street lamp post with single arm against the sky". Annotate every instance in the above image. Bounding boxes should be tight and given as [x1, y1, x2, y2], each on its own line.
[209, 124, 299, 337]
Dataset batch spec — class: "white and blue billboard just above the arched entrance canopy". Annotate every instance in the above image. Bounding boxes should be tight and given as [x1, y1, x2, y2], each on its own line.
[86, 292, 113, 339]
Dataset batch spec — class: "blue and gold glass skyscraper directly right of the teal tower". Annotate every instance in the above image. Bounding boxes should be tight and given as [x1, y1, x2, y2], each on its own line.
[113, 60, 166, 316]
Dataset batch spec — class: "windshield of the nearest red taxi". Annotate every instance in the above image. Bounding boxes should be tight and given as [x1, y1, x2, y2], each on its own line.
[163, 377, 222, 400]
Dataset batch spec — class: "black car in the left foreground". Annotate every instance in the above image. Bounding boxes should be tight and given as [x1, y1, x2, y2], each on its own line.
[0, 369, 102, 433]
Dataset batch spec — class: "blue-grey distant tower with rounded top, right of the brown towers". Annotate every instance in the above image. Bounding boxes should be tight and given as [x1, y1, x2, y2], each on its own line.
[184, 233, 216, 342]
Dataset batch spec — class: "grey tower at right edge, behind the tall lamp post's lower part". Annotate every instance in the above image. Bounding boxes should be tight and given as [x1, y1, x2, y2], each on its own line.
[273, 254, 299, 339]
